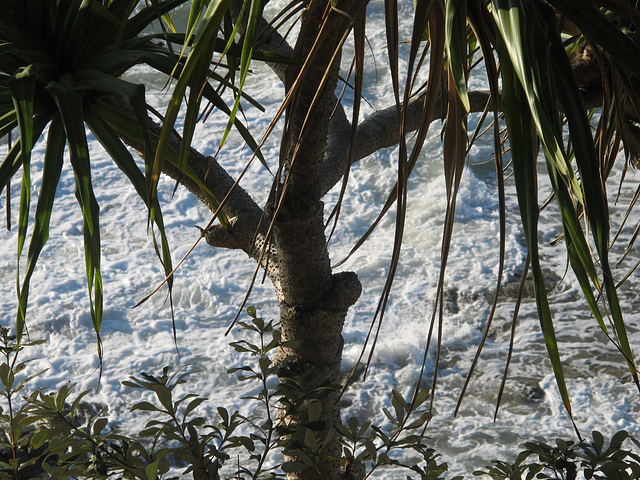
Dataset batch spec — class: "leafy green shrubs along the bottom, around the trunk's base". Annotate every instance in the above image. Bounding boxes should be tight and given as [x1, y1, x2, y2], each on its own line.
[0, 314, 640, 480]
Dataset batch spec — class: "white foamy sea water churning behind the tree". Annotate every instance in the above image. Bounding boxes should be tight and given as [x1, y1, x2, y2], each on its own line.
[0, 1, 640, 478]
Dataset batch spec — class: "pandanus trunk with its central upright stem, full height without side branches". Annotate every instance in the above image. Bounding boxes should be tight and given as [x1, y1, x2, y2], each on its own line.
[272, 0, 362, 480]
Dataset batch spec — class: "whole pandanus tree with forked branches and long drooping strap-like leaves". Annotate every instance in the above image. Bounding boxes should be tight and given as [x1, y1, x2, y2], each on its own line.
[0, 0, 640, 479]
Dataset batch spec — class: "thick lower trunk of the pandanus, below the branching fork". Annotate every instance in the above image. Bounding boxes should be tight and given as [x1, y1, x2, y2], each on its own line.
[274, 198, 362, 480]
